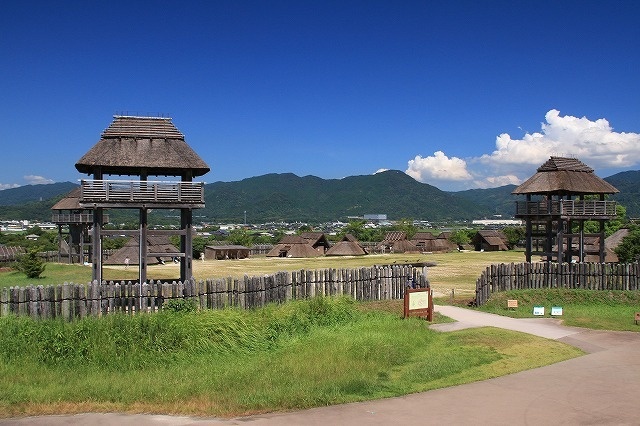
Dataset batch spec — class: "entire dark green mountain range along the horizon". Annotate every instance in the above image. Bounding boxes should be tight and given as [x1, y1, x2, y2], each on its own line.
[0, 170, 640, 223]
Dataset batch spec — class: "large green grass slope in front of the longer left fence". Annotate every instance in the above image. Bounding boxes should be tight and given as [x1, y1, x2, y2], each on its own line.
[0, 298, 581, 417]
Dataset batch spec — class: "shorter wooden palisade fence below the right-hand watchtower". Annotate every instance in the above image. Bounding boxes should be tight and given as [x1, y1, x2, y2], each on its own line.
[475, 262, 640, 306]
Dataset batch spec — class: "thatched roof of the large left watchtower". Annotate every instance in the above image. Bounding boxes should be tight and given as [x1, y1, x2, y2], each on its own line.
[76, 115, 210, 177]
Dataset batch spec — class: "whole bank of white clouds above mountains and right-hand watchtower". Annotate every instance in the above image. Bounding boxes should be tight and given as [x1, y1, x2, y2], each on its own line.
[405, 109, 640, 188]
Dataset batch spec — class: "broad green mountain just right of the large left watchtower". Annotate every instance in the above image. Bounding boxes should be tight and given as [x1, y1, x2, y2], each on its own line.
[205, 170, 487, 222]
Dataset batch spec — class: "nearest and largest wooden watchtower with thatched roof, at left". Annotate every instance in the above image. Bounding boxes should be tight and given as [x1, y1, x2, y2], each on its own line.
[76, 115, 210, 283]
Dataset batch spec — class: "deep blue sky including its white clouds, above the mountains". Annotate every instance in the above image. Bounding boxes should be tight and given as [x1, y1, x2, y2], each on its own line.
[0, 0, 640, 194]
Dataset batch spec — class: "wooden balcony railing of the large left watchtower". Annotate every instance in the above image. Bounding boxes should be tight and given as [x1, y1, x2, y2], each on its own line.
[79, 180, 204, 209]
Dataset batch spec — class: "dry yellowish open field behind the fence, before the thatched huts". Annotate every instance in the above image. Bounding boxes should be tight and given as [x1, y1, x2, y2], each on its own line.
[104, 251, 524, 296]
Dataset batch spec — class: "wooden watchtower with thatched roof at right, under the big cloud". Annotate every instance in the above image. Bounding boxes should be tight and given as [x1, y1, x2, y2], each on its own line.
[512, 157, 618, 262]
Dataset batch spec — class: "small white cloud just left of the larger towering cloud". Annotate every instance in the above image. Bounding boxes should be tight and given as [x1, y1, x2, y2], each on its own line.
[405, 151, 472, 182]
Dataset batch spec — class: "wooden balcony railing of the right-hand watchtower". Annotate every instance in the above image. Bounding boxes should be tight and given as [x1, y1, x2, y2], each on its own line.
[515, 200, 616, 220]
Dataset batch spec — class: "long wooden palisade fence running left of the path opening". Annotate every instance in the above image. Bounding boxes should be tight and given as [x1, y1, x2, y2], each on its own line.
[0, 265, 428, 320]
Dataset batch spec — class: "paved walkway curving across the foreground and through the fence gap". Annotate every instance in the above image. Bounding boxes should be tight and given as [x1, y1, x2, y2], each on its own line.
[5, 306, 640, 426]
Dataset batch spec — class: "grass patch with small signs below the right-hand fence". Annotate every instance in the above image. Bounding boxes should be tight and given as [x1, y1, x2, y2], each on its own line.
[480, 289, 640, 331]
